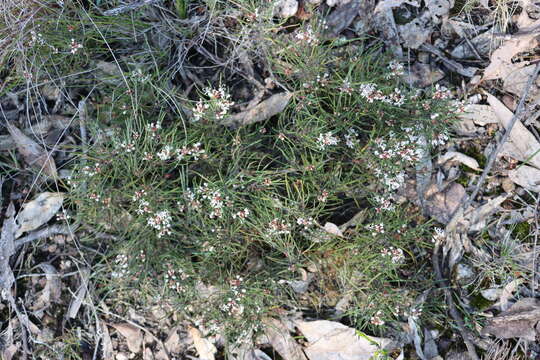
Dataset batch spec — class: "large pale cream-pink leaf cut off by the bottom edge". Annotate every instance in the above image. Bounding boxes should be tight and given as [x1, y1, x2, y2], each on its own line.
[294, 320, 394, 360]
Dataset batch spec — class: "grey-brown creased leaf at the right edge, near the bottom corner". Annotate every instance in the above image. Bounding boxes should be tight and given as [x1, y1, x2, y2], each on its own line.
[481, 298, 540, 341]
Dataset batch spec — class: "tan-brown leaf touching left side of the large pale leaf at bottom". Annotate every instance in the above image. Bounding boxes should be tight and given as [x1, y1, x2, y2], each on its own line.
[263, 319, 307, 360]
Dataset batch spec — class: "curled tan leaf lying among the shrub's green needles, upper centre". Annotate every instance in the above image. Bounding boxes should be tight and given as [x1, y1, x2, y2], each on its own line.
[221, 92, 292, 127]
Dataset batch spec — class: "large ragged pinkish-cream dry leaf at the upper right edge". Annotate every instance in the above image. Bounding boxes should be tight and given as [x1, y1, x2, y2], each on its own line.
[482, 20, 540, 80]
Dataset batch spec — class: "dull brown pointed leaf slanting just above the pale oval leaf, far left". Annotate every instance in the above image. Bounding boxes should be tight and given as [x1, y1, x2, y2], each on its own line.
[7, 122, 58, 179]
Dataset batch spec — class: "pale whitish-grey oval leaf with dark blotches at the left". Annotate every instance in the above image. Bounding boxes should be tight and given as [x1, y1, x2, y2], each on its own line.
[15, 192, 65, 238]
